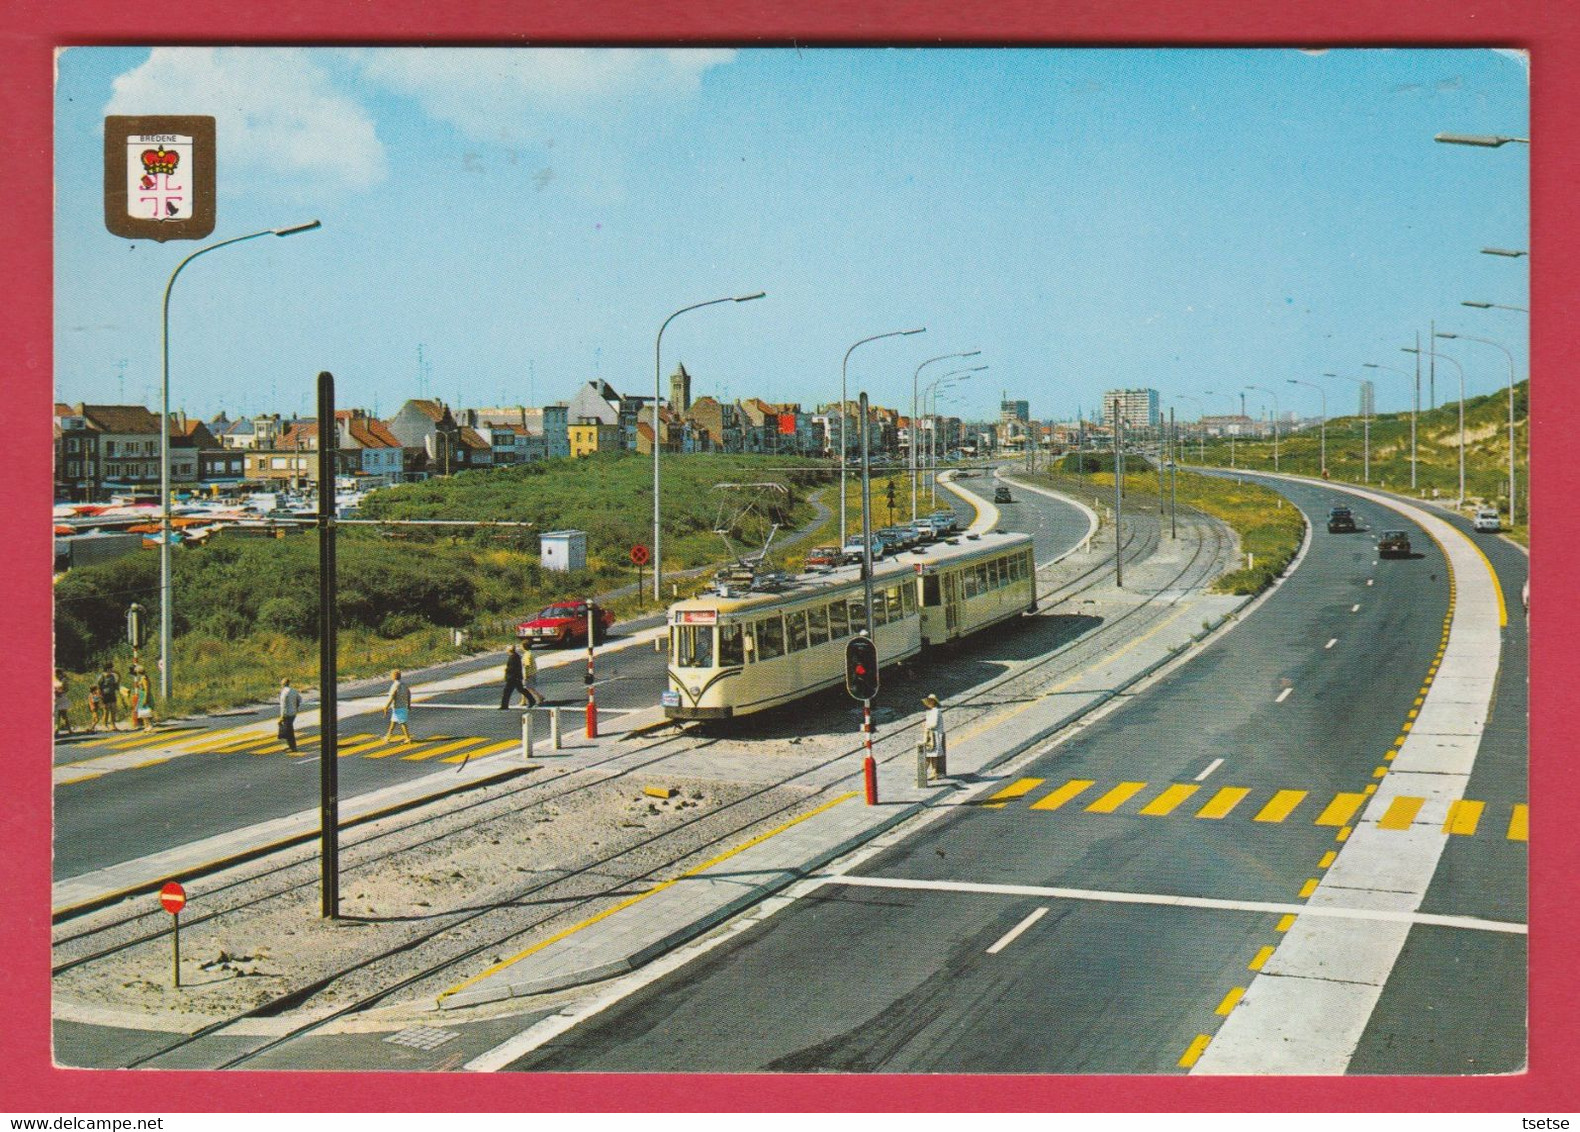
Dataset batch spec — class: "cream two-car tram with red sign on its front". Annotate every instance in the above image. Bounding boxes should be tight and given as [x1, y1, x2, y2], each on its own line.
[664, 531, 1036, 719]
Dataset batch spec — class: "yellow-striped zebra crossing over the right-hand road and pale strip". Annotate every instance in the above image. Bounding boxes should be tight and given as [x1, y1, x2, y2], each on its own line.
[975, 778, 1529, 841]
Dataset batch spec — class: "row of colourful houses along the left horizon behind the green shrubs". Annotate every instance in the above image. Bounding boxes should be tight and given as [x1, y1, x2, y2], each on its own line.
[54, 365, 962, 501]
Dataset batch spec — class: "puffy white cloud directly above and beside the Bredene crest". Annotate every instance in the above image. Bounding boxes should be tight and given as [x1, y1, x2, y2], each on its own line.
[104, 47, 387, 193]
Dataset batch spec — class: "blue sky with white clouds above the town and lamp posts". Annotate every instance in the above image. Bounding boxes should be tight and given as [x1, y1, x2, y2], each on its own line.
[55, 47, 1529, 430]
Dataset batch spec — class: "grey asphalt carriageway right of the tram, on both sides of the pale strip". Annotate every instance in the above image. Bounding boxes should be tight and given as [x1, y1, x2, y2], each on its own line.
[514, 474, 1525, 1074]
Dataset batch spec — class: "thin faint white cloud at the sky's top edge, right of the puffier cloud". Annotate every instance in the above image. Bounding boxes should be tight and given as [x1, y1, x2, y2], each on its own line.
[354, 47, 735, 138]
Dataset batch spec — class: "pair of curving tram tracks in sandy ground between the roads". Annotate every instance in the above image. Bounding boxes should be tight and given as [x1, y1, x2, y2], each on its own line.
[52, 490, 1229, 1069]
